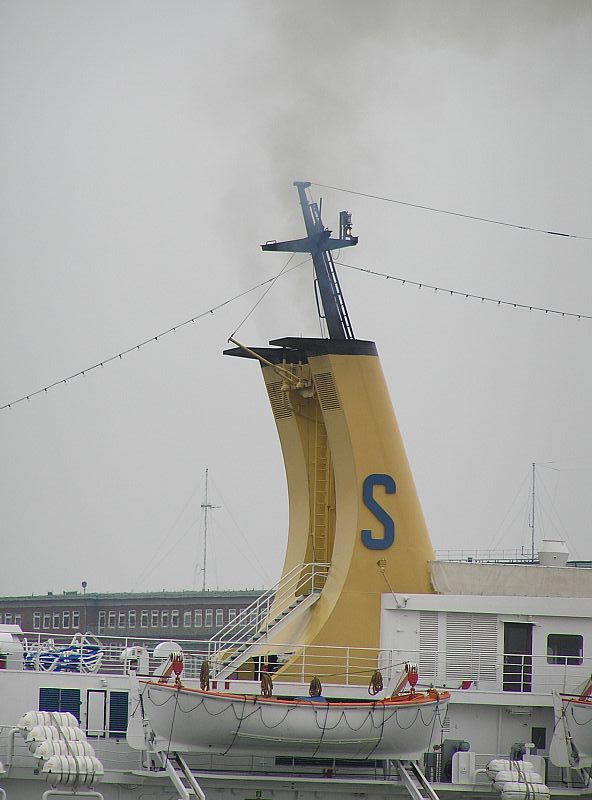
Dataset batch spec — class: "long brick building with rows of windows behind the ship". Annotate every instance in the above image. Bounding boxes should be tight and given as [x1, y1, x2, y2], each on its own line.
[0, 589, 261, 639]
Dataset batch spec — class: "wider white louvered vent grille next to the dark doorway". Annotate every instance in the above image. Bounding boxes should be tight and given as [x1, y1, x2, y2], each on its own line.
[446, 613, 497, 681]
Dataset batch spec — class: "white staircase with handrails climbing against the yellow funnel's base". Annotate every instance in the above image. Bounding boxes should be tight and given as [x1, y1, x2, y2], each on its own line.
[208, 562, 329, 680]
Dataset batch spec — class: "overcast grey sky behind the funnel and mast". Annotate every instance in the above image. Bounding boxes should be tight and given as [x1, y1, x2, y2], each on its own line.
[0, 0, 592, 594]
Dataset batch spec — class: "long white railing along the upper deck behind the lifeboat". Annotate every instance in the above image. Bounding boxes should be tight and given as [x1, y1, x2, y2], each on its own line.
[6, 632, 592, 694]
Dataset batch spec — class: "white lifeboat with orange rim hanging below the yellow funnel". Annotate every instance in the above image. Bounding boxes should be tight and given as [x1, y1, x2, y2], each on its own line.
[136, 682, 448, 759]
